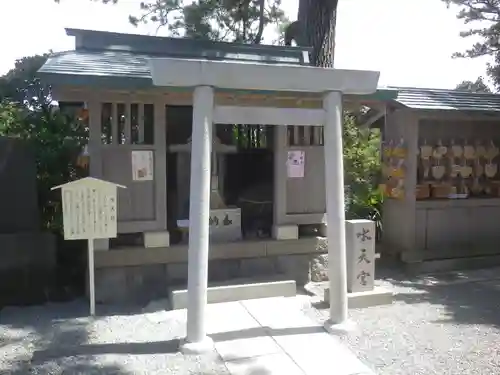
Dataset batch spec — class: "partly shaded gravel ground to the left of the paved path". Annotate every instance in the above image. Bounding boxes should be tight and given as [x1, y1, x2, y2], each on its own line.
[0, 301, 229, 375]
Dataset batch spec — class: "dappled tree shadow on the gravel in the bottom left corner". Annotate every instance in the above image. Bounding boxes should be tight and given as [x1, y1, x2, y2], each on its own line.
[0, 302, 135, 375]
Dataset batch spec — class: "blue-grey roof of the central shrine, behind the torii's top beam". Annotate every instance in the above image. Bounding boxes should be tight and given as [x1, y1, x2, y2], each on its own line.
[39, 29, 309, 88]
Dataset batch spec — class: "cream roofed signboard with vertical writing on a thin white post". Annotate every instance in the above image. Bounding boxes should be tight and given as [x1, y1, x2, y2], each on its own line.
[52, 177, 125, 316]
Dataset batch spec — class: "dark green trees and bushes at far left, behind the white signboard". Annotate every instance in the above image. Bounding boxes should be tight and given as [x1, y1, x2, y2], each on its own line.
[0, 54, 87, 234]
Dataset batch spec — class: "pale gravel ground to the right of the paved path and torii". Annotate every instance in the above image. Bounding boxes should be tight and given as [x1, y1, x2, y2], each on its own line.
[302, 268, 500, 375]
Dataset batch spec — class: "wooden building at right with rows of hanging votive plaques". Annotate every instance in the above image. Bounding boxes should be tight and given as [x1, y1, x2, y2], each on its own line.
[372, 88, 500, 270]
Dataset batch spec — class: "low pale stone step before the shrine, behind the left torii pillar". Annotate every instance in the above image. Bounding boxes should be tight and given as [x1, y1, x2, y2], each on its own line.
[170, 280, 297, 310]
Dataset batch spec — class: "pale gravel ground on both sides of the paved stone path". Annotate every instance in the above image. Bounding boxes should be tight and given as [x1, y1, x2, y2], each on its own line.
[0, 269, 500, 375]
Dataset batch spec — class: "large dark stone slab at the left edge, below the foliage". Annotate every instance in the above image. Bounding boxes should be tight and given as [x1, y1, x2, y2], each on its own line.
[0, 137, 56, 308]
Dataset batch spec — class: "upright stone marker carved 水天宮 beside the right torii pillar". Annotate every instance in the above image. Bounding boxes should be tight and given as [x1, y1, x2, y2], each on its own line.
[346, 220, 375, 293]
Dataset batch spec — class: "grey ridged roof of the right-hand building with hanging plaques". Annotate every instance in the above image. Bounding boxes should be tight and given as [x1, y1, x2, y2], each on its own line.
[391, 87, 500, 112]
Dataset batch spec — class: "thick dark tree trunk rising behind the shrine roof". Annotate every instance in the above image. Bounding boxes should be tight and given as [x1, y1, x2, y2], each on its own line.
[298, 0, 338, 68]
